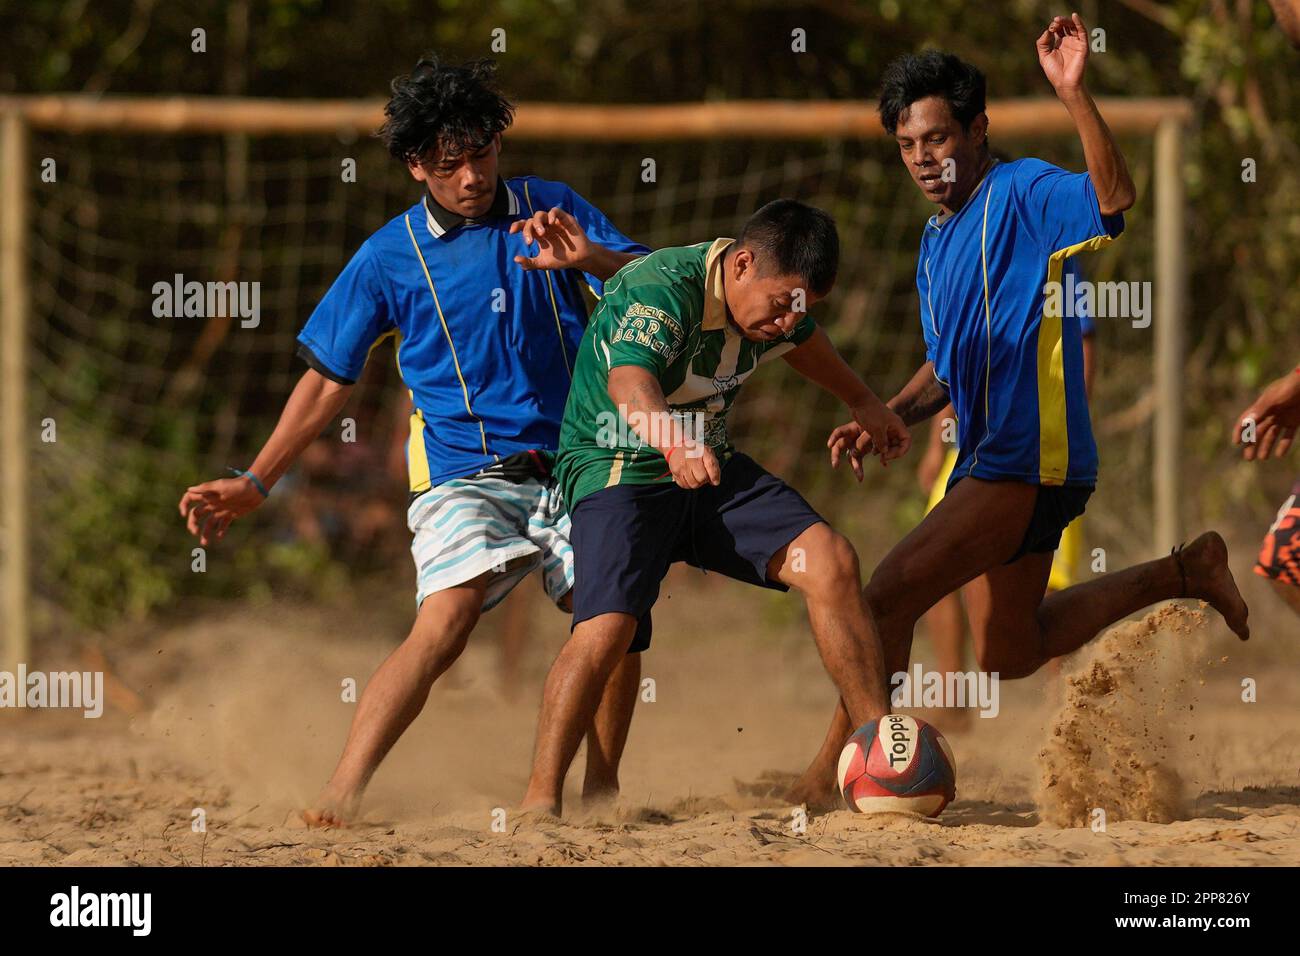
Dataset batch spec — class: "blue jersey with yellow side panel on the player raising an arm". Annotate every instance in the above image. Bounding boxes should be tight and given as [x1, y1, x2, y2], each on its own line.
[917, 159, 1125, 486]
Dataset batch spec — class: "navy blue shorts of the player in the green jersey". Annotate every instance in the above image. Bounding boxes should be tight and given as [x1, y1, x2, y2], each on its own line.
[569, 454, 823, 653]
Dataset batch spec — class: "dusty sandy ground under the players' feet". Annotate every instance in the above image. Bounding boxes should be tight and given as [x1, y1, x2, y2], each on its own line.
[0, 561, 1300, 866]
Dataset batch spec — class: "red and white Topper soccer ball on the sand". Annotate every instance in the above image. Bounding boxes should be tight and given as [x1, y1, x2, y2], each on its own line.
[836, 714, 957, 817]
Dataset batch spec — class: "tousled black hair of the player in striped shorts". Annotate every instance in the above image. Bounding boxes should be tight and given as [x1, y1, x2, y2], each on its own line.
[380, 53, 515, 163]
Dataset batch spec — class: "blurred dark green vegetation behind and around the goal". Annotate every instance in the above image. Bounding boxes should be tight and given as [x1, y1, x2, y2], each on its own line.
[0, 0, 1300, 642]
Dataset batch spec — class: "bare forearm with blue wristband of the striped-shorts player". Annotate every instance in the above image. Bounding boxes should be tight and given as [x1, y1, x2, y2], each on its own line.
[179, 369, 354, 546]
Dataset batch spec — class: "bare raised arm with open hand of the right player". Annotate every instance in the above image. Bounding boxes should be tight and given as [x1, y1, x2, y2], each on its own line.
[1037, 13, 1138, 216]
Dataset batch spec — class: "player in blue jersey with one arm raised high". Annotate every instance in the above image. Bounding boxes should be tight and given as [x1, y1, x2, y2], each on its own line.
[790, 14, 1249, 805]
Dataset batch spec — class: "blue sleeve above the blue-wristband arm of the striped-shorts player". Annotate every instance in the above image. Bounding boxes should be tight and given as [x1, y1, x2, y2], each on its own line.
[298, 243, 395, 385]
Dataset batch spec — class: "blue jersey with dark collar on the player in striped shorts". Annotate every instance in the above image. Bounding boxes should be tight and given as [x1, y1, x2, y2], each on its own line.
[298, 177, 650, 493]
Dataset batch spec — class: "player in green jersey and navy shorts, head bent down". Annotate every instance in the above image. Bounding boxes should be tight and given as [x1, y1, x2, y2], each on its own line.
[523, 199, 910, 813]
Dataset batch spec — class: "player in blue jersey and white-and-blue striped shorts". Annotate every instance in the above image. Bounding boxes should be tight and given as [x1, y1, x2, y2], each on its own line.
[179, 56, 649, 826]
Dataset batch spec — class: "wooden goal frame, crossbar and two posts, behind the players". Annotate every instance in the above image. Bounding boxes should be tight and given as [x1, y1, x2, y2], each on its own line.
[0, 95, 1192, 669]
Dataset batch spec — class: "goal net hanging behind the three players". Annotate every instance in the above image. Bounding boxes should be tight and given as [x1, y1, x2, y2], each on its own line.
[4, 97, 1180, 650]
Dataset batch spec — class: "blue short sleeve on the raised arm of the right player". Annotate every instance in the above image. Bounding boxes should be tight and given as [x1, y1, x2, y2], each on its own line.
[1011, 159, 1125, 254]
